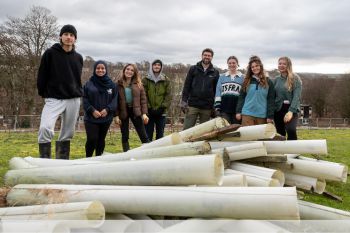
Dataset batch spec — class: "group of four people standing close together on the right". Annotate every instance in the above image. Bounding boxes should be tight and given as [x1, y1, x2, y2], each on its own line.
[181, 48, 302, 140]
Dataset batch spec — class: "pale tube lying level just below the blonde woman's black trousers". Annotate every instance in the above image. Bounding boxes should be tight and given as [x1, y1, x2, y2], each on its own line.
[264, 140, 327, 155]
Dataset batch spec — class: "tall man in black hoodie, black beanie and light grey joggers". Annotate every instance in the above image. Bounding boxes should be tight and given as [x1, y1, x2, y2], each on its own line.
[37, 24, 83, 159]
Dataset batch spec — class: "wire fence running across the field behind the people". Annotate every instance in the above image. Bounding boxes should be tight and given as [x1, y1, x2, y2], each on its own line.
[0, 115, 350, 132]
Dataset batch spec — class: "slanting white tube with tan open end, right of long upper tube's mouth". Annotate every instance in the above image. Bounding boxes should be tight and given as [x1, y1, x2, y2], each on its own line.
[230, 162, 285, 186]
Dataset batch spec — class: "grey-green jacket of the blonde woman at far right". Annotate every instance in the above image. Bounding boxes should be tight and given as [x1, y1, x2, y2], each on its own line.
[274, 75, 302, 113]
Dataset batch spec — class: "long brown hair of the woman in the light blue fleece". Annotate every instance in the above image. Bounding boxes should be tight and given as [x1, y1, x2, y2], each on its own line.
[243, 56, 269, 92]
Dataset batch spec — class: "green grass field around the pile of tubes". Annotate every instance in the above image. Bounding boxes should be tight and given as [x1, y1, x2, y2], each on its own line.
[0, 129, 350, 211]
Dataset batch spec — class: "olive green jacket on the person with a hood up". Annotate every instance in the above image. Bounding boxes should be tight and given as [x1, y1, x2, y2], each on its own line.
[142, 74, 171, 110]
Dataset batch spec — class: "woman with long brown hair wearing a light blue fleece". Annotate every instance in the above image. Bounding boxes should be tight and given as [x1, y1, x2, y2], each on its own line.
[236, 56, 275, 126]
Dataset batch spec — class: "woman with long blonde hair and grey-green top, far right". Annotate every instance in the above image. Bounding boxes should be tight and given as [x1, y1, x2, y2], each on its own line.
[274, 57, 302, 140]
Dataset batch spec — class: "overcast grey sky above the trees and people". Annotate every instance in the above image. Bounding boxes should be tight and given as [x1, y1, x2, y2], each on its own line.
[0, 0, 350, 73]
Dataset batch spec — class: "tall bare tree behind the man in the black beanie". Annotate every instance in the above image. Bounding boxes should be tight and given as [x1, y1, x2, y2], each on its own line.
[0, 6, 58, 119]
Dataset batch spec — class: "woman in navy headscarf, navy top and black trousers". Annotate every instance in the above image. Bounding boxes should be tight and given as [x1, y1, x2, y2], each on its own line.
[83, 61, 118, 157]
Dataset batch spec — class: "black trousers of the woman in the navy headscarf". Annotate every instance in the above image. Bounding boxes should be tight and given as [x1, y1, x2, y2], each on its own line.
[84, 121, 112, 157]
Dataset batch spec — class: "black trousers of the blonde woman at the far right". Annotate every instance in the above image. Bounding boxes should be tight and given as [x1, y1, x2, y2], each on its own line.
[274, 104, 298, 140]
